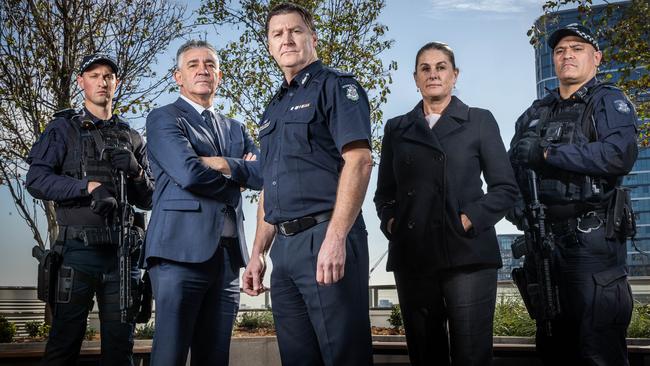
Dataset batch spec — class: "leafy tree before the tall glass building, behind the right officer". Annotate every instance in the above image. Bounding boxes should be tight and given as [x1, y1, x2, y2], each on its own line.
[528, 0, 650, 146]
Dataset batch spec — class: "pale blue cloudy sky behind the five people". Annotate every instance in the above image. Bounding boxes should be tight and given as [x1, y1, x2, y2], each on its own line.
[0, 0, 544, 286]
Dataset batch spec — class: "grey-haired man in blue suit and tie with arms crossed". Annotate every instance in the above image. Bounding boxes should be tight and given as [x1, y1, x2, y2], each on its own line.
[144, 40, 261, 365]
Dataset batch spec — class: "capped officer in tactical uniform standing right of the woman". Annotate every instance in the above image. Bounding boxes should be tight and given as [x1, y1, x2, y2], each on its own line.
[510, 24, 638, 365]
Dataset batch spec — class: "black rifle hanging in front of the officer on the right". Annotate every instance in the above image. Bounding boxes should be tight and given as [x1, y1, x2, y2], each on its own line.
[512, 170, 560, 336]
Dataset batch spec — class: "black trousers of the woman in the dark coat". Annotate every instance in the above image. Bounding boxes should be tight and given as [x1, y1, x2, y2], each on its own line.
[395, 268, 497, 366]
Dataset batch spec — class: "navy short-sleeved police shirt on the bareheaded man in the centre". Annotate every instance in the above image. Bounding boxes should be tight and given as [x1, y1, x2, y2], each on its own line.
[258, 60, 371, 224]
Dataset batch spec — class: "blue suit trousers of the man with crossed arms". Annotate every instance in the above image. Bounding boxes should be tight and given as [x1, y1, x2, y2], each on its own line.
[149, 238, 240, 366]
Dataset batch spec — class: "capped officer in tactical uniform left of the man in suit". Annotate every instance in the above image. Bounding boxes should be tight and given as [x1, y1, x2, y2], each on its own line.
[27, 54, 153, 365]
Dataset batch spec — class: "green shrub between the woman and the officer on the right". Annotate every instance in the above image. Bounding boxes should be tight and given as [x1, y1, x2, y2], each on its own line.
[493, 296, 536, 337]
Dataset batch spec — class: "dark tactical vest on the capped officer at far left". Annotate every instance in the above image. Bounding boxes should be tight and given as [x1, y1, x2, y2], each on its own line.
[55, 108, 133, 206]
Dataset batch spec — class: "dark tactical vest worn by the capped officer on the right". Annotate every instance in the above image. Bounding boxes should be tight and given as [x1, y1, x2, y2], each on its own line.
[526, 83, 617, 207]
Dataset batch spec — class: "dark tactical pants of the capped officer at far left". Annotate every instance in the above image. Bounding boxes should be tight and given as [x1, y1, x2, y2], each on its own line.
[41, 239, 140, 366]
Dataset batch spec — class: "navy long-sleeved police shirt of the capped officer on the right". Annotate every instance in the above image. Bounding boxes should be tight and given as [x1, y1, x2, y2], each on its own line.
[515, 78, 638, 176]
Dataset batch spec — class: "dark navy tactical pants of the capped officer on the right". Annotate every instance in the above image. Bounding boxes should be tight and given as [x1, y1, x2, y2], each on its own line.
[525, 220, 632, 366]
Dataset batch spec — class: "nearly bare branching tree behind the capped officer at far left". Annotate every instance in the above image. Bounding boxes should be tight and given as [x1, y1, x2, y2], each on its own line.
[0, 0, 188, 246]
